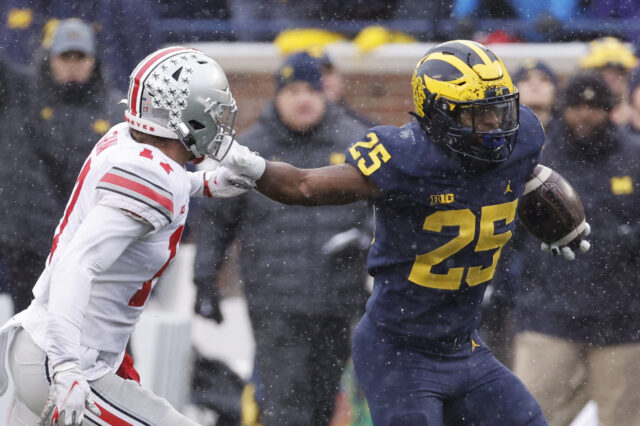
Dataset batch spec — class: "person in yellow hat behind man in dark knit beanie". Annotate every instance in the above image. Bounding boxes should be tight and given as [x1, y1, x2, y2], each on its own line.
[580, 37, 638, 125]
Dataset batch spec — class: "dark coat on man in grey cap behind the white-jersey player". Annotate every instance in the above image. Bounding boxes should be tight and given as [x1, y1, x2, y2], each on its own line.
[0, 50, 124, 311]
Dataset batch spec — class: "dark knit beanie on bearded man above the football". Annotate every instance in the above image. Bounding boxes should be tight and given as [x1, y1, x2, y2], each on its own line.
[563, 71, 613, 111]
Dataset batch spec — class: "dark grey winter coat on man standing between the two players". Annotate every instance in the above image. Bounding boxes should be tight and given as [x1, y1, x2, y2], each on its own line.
[195, 104, 369, 317]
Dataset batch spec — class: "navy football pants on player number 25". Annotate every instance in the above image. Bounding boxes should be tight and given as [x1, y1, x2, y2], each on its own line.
[352, 315, 547, 426]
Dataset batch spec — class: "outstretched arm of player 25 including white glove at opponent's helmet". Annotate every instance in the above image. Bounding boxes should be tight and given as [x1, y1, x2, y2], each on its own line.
[222, 142, 382, 206]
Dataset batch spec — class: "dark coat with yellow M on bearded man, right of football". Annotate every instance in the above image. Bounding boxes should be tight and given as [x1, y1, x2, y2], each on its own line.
[517, 120, 640, 345]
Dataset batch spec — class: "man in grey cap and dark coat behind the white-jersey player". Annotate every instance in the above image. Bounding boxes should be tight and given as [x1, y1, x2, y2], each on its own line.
[3, 19, 124, 312]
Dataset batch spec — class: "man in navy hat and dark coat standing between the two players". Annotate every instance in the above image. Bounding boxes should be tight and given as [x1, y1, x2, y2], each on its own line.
[195, 53, 370, 426]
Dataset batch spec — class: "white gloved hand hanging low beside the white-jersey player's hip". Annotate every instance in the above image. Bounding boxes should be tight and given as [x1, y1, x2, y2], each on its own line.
[39, 361, 100, 426]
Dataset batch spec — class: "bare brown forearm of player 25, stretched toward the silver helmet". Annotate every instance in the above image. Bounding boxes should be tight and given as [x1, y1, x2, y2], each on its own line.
[257, 161, 377, 206]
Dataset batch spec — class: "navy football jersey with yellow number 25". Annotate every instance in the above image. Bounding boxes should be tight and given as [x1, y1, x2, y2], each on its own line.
[346, 106, 544, 341]
